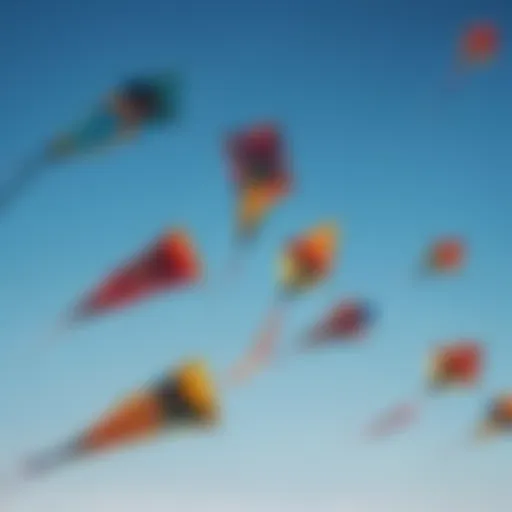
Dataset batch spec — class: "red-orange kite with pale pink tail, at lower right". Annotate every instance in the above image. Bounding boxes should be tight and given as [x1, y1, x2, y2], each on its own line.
[367, 340, 484, 439]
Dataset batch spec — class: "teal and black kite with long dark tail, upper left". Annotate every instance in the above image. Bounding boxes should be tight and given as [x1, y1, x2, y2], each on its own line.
[0, 73, 178, 213]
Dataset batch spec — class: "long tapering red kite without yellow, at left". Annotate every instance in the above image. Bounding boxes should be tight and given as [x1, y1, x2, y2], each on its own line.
[43, 230, 202, 344]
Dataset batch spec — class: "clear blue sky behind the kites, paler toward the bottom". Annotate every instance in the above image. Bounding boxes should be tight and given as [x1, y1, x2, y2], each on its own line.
[0, 0, 512, 512]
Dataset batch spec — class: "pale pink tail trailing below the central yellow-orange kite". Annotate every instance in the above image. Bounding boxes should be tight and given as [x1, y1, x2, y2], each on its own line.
[223, 301, 286, 386]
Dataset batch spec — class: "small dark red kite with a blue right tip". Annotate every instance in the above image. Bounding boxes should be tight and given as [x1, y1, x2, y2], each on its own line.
[304, 300, 376, 347]
